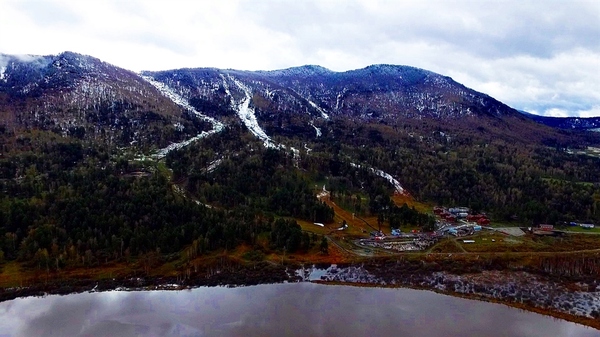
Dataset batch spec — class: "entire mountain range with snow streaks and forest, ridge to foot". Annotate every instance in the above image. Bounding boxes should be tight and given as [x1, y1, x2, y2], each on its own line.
[0, 52, 600, 287]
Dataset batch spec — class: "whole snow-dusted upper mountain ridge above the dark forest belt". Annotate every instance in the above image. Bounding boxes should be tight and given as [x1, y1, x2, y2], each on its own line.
[0, 52, 596, 154]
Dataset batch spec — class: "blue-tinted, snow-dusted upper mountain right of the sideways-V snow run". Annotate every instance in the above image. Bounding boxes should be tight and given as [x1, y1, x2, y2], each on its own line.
[142, 65, 576, 150]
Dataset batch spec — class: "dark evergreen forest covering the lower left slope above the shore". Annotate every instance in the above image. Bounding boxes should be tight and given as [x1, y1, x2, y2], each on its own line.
[0, 127, 333, 269]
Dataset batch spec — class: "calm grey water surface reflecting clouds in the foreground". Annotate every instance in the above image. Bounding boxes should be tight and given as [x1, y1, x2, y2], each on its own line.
[0, 283, 600, 337]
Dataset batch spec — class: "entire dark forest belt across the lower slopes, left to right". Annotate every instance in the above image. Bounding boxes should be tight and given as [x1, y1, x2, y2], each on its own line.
[0, 111, 600, 269]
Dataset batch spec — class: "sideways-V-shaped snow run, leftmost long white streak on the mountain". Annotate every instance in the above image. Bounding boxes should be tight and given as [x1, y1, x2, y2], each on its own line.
[141, 76, 225, 159]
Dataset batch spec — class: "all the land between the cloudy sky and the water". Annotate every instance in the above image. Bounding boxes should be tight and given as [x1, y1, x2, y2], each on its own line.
[0, 53, 600, 328]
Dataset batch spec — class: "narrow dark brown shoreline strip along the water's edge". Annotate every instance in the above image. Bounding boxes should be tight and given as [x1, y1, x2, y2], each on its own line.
[0, 262, 600, 330]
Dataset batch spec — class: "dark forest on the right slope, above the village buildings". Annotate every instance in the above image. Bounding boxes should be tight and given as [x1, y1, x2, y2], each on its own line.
[288, 120, 600, 224]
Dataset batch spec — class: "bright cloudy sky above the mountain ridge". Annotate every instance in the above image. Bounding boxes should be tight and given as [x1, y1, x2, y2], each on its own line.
[0, 0, 600, 116]
